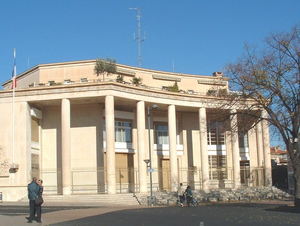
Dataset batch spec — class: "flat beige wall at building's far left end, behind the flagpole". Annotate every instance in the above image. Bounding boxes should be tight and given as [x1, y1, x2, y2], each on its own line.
[0, 97, 31, 201]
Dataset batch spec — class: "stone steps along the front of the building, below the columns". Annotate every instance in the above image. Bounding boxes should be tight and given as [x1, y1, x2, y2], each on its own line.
[20, 187, 293, 206]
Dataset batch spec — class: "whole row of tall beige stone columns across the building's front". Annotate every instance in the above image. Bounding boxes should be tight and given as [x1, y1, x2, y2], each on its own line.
[61, 96, 271, 195]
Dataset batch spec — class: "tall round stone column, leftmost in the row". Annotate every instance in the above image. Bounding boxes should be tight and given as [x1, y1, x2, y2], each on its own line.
[61, 99, 72, 195]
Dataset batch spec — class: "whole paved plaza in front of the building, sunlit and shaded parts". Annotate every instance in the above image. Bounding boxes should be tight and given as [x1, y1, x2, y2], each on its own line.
[0, 201, 300, 226]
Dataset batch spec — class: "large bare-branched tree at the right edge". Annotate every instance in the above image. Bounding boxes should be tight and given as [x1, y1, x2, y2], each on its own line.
[227, 24, 300, 207]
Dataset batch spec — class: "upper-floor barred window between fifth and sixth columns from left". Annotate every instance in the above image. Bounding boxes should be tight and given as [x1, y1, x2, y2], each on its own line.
[207, 122, 225, 145]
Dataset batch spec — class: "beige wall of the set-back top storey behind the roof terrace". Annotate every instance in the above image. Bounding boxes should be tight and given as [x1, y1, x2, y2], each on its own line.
[4, 60, 228, 94]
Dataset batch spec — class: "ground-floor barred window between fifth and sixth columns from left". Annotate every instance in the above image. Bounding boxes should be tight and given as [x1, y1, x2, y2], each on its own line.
[208, 155, 227, 180]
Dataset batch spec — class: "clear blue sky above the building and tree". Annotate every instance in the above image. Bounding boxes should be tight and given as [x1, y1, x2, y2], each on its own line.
[0, 0, 300, 147]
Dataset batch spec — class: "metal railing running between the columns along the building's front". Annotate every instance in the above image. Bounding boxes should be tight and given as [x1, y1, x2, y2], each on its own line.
[31, 165, 265, 194]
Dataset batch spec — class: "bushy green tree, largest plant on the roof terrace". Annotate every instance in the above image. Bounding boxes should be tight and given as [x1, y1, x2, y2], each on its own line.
[94, 57, 117, 81]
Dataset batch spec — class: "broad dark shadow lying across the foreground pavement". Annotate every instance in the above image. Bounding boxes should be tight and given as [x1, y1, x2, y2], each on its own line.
[45, 203, 300, 226]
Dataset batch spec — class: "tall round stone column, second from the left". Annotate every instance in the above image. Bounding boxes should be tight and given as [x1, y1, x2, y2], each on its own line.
[105, 96, 116, 194]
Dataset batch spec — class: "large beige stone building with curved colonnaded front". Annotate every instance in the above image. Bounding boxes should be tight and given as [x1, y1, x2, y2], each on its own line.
[0, 60, 272, 201]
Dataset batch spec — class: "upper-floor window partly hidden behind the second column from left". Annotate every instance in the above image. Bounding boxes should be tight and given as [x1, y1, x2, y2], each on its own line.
[103, 120, 132, 143]
